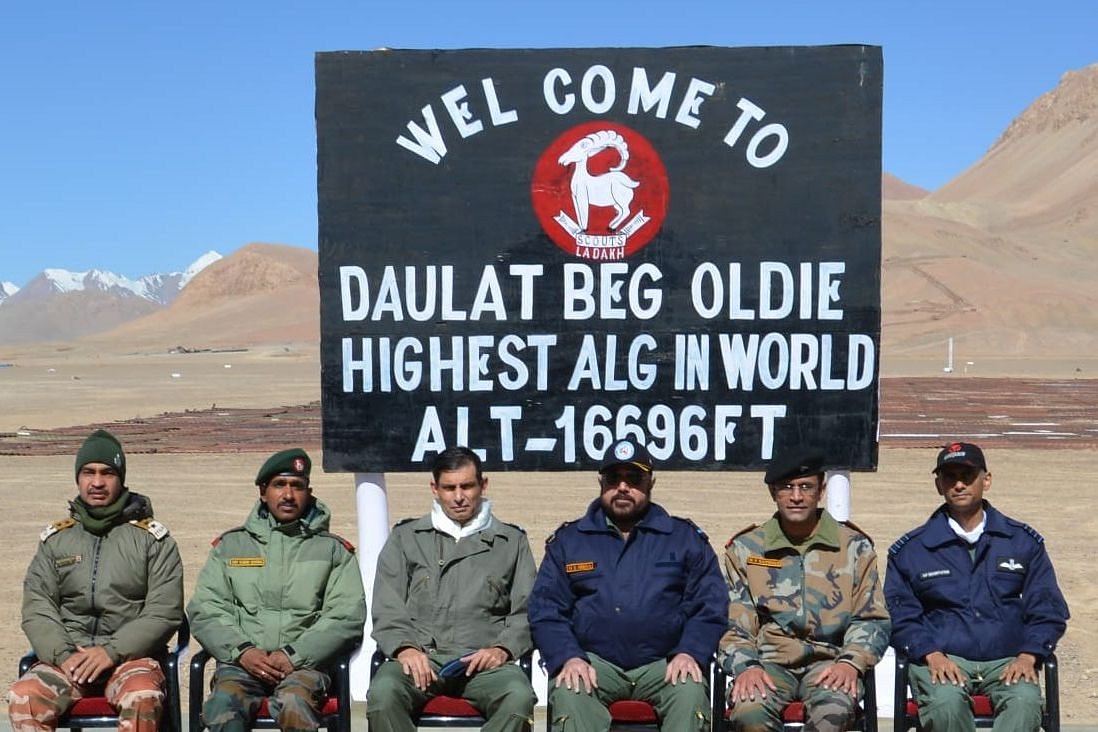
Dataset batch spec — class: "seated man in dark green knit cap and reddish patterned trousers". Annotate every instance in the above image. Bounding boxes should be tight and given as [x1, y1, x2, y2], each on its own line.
[8, 430, 183, 732]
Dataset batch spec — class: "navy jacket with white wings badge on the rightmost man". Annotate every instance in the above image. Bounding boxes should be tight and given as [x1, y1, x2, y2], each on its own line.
[885, 502, 1068, 661]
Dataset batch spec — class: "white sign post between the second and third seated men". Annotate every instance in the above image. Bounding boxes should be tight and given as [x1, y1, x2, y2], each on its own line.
[350, 473, 389, 701]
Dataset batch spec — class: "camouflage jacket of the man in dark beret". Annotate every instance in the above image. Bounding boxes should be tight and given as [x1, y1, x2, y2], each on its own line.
[720, 511, 890, 674]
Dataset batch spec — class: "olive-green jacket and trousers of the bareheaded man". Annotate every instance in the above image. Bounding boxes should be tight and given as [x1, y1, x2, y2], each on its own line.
[367, 515, 536, 732]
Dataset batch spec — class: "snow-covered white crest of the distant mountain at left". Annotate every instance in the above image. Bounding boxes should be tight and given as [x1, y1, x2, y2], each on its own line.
[0, 251, 221, 305]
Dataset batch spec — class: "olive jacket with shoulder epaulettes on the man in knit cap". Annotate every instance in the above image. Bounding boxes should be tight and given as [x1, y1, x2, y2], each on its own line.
[23, 493, 183, 665]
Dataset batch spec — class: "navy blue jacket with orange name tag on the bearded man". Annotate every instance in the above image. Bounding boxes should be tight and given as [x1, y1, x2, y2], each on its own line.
[530, 498, 728, 675]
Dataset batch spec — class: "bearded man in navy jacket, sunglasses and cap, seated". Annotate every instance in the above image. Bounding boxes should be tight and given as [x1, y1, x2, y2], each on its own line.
[529, 440, 728, 732]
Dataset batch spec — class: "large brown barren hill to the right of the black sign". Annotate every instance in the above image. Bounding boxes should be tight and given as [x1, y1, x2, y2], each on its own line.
[882, 65, 1098, 378]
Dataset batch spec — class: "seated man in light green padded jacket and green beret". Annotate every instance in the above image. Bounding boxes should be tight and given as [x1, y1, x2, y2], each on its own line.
[187, 448, 366, 732]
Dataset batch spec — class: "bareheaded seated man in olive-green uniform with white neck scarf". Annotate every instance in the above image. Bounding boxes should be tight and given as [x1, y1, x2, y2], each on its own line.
[366, 448, 537, 732]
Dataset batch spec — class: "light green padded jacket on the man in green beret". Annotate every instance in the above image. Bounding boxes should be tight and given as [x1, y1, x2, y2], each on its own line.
[187, 499, 366, 668]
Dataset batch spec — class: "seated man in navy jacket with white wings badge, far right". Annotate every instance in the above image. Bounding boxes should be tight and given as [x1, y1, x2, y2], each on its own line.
[885, 442, 1068, 731]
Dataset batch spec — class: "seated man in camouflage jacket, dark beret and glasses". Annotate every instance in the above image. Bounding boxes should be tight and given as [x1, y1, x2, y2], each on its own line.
[720, 449, 889, 732]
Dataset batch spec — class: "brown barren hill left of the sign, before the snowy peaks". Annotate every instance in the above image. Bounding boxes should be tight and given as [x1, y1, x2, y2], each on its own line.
[102, 244, 320, 348]
